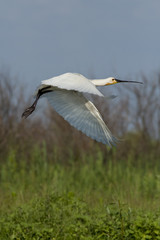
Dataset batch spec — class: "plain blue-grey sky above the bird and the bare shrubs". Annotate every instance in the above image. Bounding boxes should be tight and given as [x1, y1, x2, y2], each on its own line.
[0, 0, 160, 90]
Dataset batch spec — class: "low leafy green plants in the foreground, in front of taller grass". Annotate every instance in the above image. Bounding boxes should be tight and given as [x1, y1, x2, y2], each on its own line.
[0, 192, 160, 240]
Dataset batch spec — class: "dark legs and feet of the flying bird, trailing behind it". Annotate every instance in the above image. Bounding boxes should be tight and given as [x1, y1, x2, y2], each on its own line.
[22, 86, 52, 118]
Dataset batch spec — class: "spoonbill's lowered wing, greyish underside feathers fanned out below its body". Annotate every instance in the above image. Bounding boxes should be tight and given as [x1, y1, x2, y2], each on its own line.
[45, 89, 115, 145]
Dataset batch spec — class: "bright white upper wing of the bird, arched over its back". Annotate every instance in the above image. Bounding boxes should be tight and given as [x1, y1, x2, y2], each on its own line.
[40, 73, 103, 97]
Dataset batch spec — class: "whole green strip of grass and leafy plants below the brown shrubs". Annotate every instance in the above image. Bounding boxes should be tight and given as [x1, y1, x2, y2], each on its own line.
[0, 146, 160, 240]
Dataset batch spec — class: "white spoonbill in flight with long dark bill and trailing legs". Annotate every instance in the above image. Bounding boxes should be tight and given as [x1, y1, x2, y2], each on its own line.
[22, 73, 141, 146]
